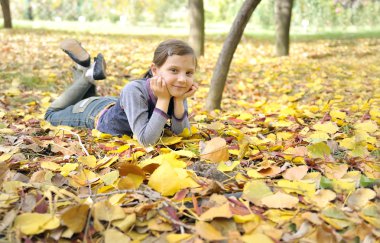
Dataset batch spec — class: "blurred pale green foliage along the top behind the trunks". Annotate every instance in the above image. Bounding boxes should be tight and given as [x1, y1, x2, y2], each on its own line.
[4, 0, 380, 32]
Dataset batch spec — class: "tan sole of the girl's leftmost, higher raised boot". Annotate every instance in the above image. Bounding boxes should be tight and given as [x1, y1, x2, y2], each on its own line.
[60, 39, 91, 67]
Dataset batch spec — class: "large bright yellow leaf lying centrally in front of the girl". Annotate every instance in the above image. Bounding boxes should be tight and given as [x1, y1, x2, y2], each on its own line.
[148, 163, 181, 196]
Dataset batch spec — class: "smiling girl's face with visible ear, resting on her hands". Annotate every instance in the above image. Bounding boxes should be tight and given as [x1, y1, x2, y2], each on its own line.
[151, 54, 195, 97]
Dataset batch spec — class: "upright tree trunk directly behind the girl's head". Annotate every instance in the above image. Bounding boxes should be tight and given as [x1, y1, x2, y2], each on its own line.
[189, 0, 205, 57]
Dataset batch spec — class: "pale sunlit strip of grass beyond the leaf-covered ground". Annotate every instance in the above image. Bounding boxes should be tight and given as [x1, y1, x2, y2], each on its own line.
[2, 20, 380, 41]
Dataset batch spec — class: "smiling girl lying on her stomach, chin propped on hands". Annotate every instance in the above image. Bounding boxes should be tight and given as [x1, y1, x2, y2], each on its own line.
[45, 39, 198, 146]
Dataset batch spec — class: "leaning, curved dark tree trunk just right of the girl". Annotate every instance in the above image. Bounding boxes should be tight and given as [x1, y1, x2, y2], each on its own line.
[206, 0, 261, 110]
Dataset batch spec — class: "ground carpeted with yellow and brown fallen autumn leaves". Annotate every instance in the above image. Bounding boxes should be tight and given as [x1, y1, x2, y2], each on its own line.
[0, 30, 380, 242]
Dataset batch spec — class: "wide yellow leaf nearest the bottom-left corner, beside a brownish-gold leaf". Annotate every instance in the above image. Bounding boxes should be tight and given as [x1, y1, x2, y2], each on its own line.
[14, 213, 59, 235]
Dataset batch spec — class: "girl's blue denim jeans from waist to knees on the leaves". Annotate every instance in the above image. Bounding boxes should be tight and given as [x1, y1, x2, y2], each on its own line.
[45, 96, 117, 129]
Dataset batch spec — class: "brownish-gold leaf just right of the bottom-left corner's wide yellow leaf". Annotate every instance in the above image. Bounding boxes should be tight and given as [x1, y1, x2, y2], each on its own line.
[61, 204, 90, 233]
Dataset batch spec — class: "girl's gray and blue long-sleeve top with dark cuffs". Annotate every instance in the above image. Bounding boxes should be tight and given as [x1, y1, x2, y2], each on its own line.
[97, 79, 190, 146]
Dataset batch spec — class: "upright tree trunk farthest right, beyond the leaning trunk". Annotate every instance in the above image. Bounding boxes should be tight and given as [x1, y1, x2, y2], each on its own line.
[274, 0, 293, 56]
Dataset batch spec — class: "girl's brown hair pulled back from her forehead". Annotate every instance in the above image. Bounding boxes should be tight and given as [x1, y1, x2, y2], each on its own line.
[144, 39, 197, 78]
